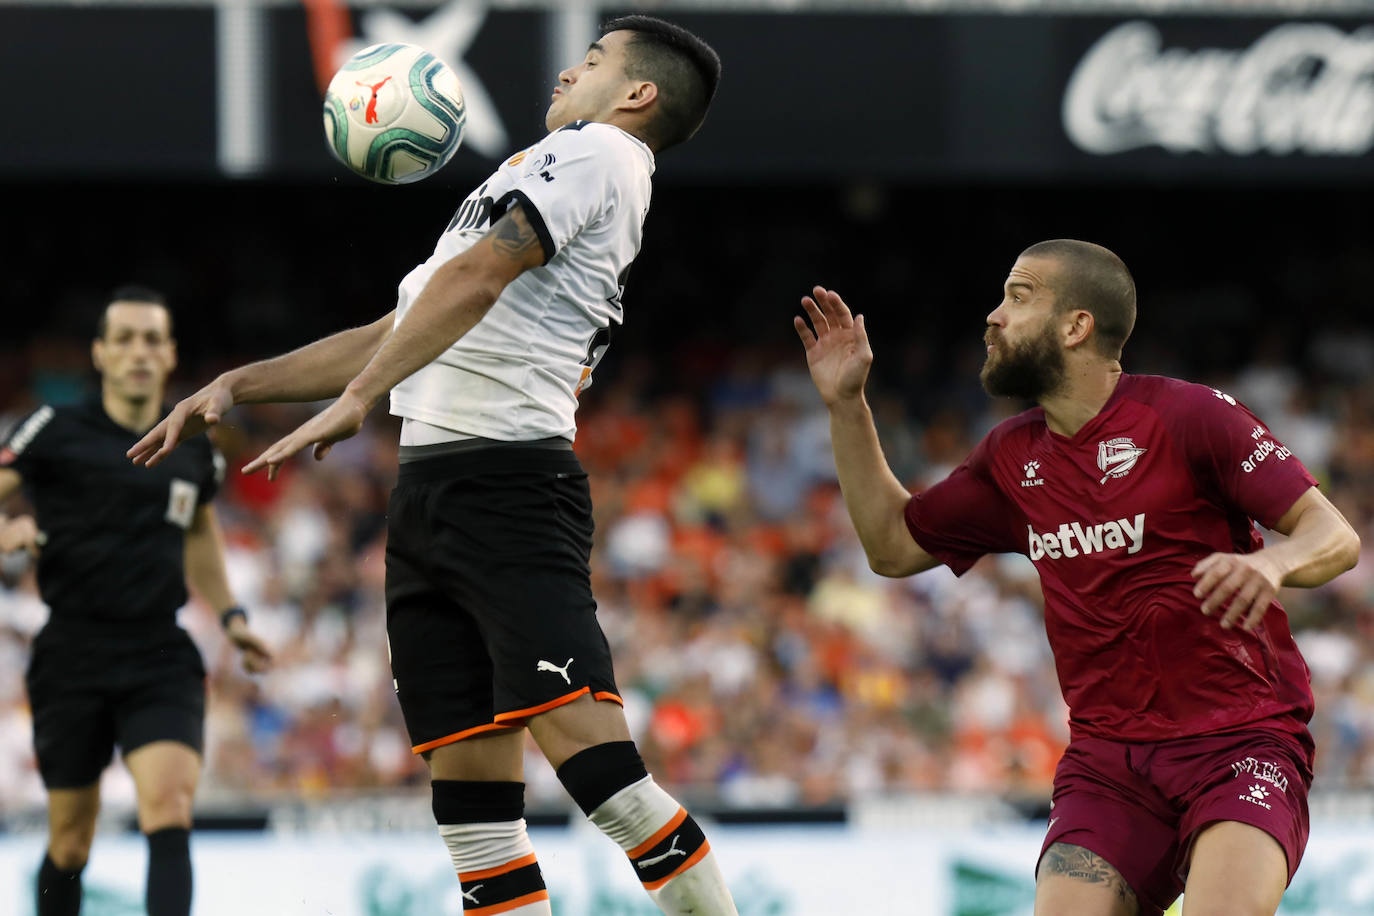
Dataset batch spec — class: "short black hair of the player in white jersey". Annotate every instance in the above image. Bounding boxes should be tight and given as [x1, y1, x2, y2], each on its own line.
[602, 15, 720, 150]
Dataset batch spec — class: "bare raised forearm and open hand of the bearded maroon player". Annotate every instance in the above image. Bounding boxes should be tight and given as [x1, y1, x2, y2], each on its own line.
[793, 286, 938, 577]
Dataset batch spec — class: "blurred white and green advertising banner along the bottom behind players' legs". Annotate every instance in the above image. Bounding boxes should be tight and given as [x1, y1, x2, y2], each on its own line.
[0, 824, 1374, 916]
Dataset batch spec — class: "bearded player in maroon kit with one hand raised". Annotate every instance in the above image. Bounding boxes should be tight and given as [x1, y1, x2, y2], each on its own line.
[794, 239, 1359, 916]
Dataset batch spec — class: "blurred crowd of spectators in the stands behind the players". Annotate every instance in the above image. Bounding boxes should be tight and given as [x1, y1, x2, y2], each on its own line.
[0, 330, 1374, 810]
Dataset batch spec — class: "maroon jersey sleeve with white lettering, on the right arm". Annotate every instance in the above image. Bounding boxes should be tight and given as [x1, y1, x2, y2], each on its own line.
[1173, 386, 1316, 529]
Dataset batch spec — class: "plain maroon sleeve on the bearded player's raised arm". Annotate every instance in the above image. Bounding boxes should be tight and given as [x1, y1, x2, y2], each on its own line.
[905, 437, 1022, 575]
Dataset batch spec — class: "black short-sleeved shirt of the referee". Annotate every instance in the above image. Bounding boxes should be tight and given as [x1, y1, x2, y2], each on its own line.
[0, 398, 224, 622]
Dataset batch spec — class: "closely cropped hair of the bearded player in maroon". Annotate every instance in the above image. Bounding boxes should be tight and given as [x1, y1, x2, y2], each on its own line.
[1021, 239, 1135, 360]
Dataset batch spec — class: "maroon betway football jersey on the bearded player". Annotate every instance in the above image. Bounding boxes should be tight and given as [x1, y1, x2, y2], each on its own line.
[905, 375, 1316, 742]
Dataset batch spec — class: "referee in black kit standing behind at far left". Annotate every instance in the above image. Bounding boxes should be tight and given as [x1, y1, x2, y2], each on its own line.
[0, 287, 271, 916]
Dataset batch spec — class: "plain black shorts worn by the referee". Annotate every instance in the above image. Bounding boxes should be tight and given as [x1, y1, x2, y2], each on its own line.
[25, 621, 205, 788]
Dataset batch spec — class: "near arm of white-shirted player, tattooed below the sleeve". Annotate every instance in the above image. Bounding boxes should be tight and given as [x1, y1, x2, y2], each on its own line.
[243, 203, 550, 479]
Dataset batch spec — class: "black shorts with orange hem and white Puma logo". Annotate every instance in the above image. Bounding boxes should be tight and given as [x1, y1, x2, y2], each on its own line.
[386, 444, 621, 754]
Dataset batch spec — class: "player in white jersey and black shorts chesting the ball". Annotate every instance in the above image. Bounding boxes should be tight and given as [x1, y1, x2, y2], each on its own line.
[129, 16, 735, 916]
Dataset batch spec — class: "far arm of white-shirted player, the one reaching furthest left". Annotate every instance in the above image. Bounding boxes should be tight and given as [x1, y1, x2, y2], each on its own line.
[128, 310, 396, 467]
